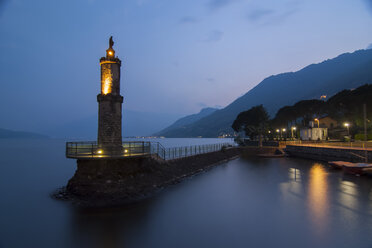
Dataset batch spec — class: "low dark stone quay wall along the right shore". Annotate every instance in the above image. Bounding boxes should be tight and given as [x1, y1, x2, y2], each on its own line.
[285, 145, 372, 162]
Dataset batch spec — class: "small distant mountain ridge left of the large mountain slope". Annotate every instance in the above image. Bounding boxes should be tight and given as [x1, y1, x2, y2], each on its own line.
[154, 108, 218, 136]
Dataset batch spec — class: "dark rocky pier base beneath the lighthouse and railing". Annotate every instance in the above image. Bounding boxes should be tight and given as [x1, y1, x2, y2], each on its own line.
[53, 147, 242, 208]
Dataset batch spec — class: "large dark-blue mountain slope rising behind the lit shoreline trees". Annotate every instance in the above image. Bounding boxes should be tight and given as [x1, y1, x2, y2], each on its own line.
[163, 49, 372, 137]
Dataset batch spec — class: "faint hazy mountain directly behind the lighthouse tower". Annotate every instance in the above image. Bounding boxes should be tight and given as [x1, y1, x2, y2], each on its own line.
[46, 109, 180, 140]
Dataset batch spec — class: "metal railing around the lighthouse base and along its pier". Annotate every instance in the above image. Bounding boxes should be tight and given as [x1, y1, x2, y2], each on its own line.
[66, 141, 232, 160]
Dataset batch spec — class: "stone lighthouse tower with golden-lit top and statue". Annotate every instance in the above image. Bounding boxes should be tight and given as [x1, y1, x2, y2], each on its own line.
[97, 36, 123, 154]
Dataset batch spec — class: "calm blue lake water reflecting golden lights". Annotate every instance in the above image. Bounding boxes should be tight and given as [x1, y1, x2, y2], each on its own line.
[0, 139, 372, 248]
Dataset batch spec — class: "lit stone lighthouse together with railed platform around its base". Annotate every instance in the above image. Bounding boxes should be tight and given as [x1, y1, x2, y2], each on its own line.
[66, 37, 155, 158]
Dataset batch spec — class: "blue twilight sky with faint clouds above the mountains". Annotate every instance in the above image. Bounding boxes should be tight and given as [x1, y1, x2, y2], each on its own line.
[0, 0, 372, 134]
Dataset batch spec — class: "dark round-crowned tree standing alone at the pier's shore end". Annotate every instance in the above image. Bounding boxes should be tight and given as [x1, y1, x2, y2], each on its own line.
[231, 105, 269, 147]
